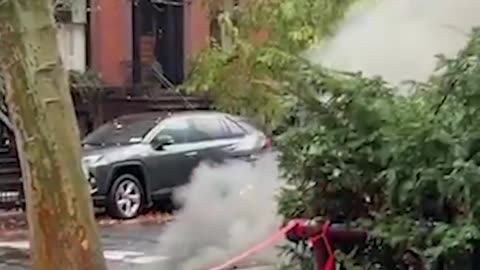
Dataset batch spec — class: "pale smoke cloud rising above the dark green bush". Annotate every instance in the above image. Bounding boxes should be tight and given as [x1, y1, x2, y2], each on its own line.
[306, 0, 480, 85]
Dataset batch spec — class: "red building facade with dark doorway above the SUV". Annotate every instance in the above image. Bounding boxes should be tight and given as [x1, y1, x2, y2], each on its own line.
[89, 0, 210, 88]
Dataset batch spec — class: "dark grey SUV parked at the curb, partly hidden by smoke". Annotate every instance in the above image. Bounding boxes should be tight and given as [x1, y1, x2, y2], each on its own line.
[82, 111, 270, 219]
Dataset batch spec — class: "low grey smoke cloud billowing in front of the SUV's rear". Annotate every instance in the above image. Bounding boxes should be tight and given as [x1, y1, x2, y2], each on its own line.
[143, 155, 281, 270]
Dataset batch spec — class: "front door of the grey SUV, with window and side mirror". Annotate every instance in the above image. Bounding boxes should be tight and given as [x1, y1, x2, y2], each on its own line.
[145, 117, 199, 196]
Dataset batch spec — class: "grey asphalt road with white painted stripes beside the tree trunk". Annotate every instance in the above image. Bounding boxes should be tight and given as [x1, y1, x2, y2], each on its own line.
[0, 221, 272, 270]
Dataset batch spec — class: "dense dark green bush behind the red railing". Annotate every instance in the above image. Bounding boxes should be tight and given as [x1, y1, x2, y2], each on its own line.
[278, 29, 480, 269]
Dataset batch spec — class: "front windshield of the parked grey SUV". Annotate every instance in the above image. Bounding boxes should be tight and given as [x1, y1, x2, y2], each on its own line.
[83, 117, 158, 145]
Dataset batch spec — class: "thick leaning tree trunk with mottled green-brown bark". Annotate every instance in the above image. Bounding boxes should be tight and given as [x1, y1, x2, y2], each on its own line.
[0, 0, 106, 270]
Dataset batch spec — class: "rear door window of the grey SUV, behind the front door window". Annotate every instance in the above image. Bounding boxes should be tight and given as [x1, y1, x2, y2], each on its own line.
[189, 116, 230, 142]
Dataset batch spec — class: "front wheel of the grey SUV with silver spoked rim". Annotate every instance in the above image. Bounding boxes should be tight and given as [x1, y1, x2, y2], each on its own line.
[106, 174, 145, 219]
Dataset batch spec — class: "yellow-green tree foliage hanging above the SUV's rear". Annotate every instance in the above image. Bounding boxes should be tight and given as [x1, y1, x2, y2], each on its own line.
[185, 0, 354, 129]
